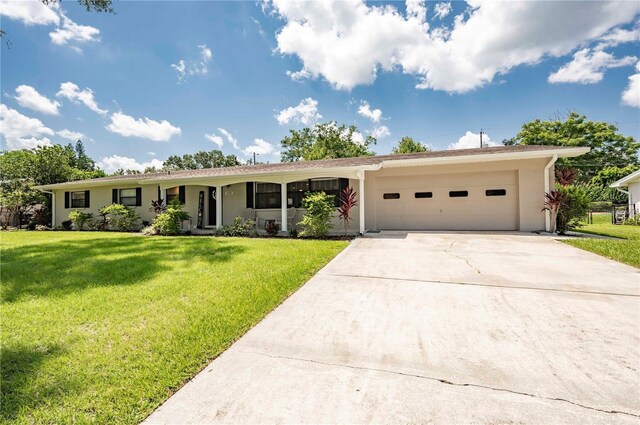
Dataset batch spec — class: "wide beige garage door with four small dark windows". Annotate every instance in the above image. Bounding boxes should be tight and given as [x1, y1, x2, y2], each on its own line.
[376, 171, 518, 230]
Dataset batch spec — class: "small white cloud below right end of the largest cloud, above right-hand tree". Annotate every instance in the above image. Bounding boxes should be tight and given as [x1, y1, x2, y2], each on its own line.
[548, 48, 638, 84]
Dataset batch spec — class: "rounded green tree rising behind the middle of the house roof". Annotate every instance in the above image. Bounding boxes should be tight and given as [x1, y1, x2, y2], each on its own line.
[282, 121, 376, 162]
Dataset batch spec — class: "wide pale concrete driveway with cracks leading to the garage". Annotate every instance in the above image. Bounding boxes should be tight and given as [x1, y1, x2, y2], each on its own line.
[147, 233, 640, 424]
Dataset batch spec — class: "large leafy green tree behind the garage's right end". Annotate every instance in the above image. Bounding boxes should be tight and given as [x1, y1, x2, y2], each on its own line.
[503, 112, 640, 183]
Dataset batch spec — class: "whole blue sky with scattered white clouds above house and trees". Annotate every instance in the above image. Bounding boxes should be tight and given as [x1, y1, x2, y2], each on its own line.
[1, 0, 640, 171]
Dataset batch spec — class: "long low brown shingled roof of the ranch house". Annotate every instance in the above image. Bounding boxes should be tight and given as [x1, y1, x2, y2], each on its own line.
[35, 145, 584, 187]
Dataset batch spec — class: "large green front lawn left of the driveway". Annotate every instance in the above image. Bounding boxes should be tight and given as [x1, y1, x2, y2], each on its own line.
[0, 232, 347, 423]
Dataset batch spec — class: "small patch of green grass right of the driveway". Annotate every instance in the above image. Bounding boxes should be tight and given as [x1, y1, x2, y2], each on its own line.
[563, 214, 640, 268]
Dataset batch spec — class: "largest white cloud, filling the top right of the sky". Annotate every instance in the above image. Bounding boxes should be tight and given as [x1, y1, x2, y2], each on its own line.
[271, 0, 640, 93]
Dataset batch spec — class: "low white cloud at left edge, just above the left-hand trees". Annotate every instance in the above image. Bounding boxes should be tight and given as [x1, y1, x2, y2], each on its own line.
[0, 104, 54, 150]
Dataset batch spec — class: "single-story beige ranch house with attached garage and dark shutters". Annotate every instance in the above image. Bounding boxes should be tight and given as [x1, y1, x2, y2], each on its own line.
[32, 146, 589, 233]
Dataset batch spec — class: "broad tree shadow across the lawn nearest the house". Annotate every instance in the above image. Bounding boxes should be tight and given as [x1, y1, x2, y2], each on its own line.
[1, 236, 246, 302]
